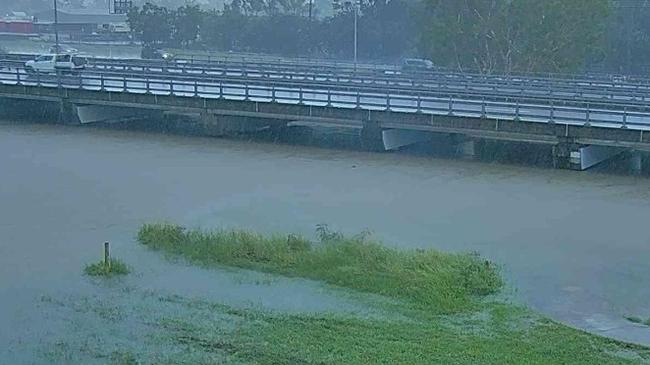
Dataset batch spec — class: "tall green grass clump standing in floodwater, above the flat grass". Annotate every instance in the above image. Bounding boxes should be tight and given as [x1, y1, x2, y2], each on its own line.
[138, 224, 503, 313]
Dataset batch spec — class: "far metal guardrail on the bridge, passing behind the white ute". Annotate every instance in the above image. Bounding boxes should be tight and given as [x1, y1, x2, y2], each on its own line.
[5, 55, 650, 106]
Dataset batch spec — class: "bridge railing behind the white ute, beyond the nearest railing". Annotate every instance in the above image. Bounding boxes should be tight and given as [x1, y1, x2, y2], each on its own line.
[5, 55, 650, 102]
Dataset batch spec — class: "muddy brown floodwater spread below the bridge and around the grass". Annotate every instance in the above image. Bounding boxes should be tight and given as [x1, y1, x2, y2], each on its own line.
[0, 122, 650, 362]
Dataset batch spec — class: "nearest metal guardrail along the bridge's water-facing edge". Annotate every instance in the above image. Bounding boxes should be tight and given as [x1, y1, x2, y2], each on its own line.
[0, 69, 650, 129]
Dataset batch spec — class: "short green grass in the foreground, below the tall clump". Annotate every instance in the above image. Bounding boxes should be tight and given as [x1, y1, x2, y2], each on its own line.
[153, 301, 650, 365]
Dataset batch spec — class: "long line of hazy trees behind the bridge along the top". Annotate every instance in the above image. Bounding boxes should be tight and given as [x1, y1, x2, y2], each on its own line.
[128, 0, 650, 73]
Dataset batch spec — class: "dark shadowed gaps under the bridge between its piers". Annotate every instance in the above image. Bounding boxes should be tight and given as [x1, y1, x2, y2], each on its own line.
[87, 117, 650, 176]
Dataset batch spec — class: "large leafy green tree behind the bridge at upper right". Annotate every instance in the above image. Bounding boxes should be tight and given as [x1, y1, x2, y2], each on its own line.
[419, 0, 609, 73]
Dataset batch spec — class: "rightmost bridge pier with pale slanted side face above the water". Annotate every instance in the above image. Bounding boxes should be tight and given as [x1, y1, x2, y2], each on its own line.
[553, 142, 624, 171]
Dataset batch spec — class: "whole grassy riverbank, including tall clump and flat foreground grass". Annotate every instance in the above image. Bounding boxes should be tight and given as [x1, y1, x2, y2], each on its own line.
[45, 224, 650, 365]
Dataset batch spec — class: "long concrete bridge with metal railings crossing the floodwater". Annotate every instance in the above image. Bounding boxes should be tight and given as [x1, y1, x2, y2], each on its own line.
[0, 57, 650, 170]
